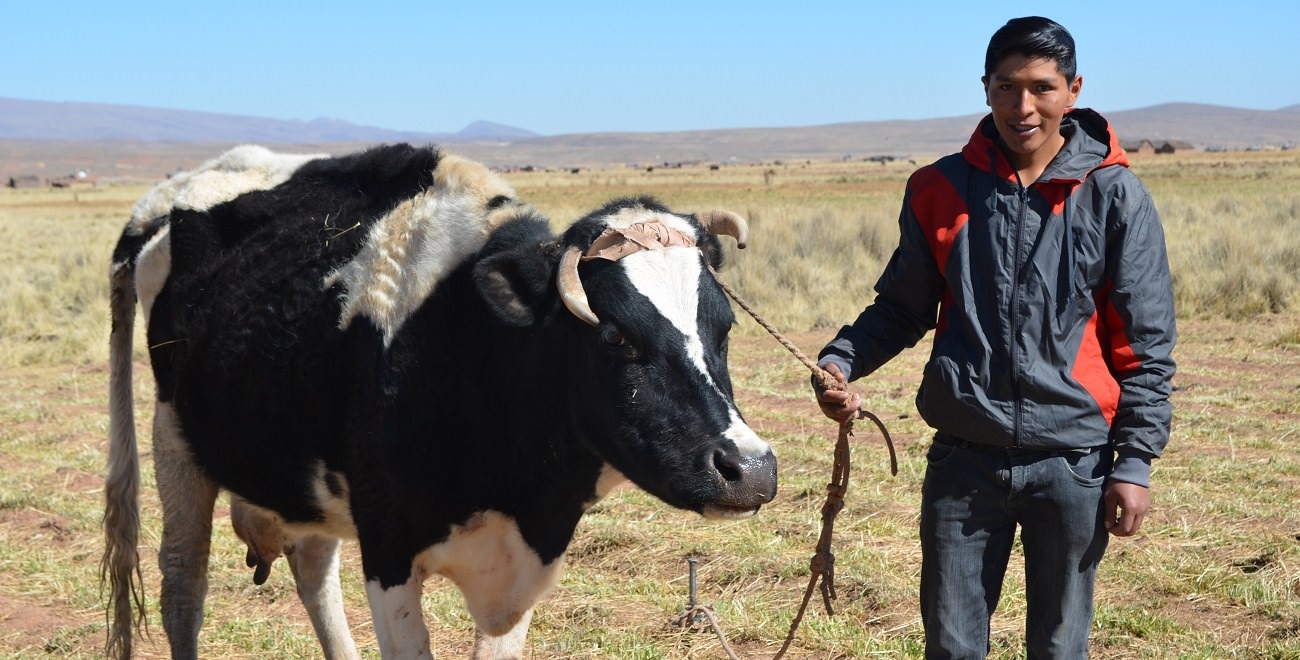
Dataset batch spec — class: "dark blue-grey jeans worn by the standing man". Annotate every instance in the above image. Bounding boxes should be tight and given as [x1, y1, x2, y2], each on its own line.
[920, 434, 1113, 659]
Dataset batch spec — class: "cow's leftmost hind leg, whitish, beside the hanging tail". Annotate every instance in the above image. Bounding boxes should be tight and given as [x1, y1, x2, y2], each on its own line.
[153, 403, 217, 659]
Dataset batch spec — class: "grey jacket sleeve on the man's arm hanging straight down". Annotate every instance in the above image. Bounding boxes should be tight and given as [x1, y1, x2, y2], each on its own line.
[1102, 171, 1177, 486]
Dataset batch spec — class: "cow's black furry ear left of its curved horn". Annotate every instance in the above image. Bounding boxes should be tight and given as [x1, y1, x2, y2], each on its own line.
[475, 246, 555, 327]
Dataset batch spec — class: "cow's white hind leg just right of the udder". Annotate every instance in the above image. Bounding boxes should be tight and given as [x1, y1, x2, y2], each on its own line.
[287, 534, 361, 660]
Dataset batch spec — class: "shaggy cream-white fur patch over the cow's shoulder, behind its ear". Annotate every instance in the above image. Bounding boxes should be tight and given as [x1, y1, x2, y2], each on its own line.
[324, 156, 515, 346]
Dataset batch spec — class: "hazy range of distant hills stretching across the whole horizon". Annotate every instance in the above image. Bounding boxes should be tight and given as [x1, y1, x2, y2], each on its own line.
[0, 99, 1300, 181]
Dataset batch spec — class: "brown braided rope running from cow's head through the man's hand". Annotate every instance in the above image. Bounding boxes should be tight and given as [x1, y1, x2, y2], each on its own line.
[706, 266, 898, 660]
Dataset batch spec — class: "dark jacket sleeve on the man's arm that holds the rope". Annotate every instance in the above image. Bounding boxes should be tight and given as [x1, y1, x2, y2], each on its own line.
[818, 183, 944, 381]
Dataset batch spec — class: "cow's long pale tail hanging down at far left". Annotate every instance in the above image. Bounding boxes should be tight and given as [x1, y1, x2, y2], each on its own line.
[99, 236, 144, 657]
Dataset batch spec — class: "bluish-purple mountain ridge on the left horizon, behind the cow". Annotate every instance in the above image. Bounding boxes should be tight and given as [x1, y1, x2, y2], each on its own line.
[0, 99, 537, 144]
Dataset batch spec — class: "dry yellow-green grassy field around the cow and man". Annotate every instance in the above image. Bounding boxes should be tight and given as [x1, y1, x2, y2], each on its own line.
[0, 152, 1300, 659]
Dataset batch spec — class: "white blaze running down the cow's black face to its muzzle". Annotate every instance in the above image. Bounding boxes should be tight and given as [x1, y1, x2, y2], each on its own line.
[608, 212, 771, 456]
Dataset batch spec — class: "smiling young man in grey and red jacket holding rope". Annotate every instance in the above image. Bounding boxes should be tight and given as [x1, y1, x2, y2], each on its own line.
[815, 17, 1175, 657]
